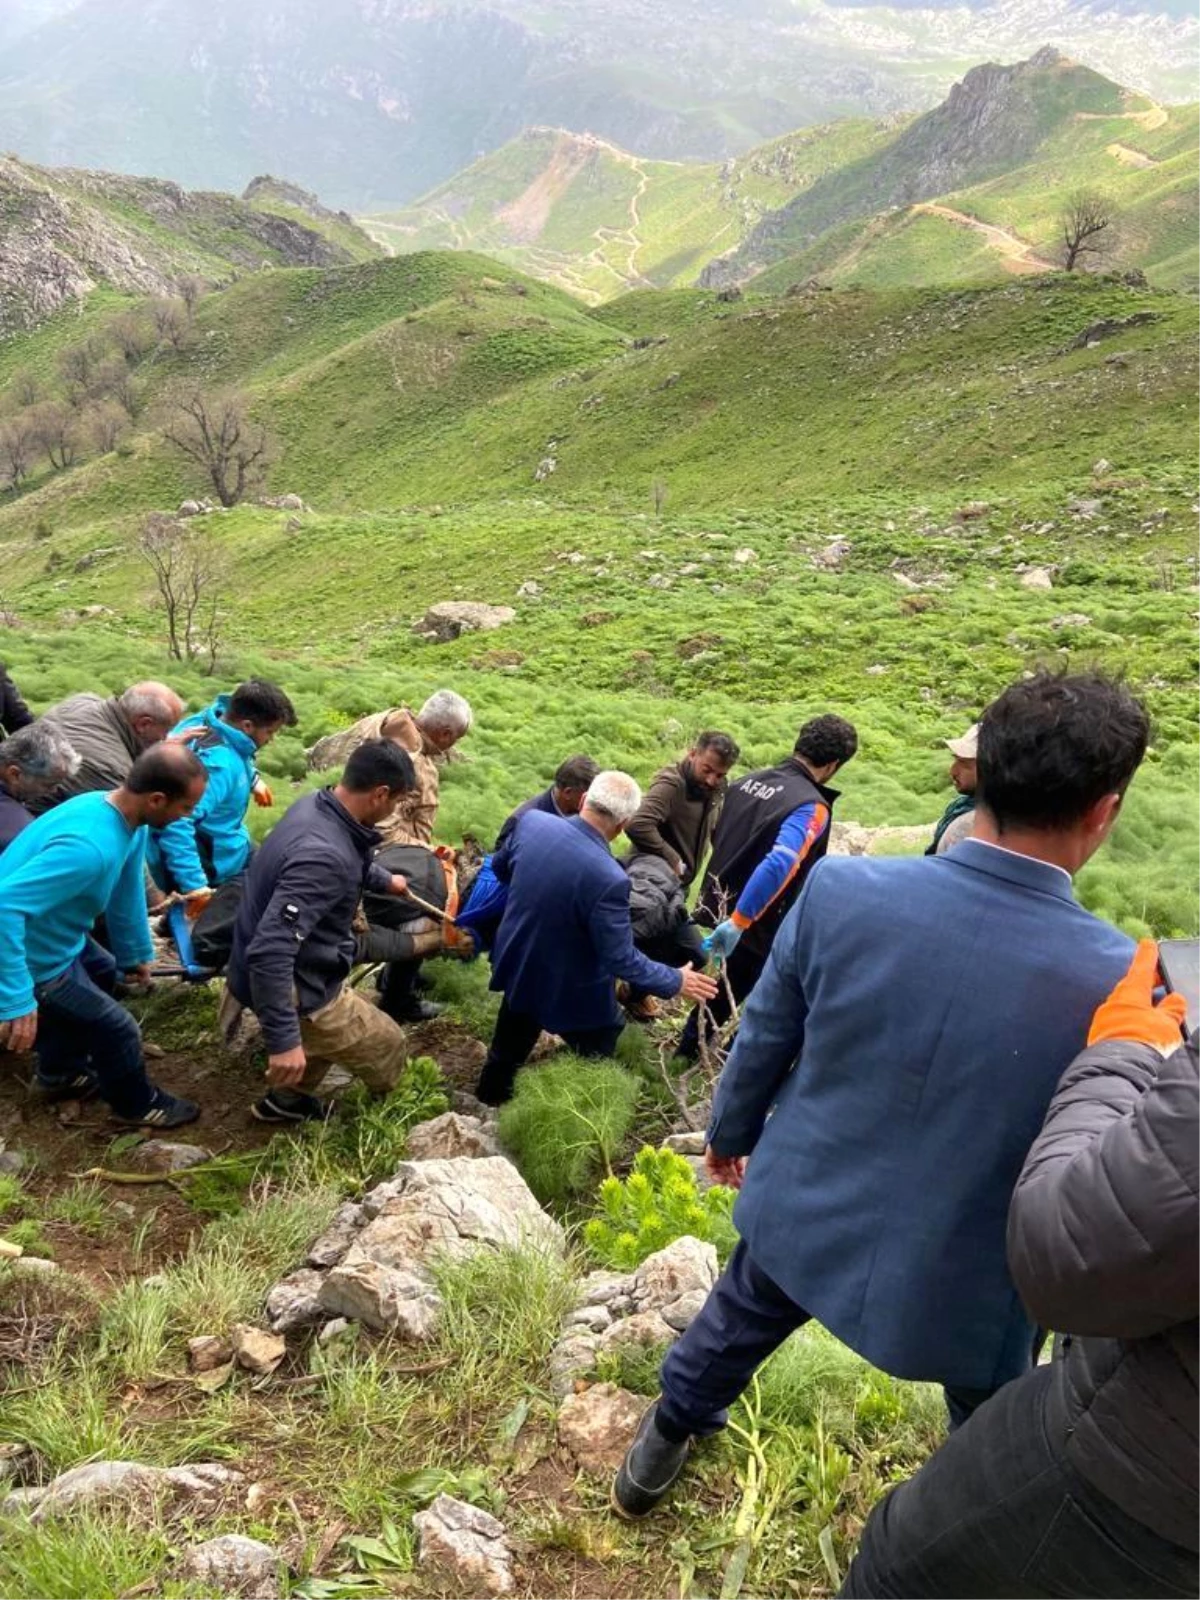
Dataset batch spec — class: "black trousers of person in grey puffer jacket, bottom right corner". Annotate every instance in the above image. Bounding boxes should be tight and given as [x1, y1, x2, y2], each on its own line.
[838, 1366, 1200, 1600]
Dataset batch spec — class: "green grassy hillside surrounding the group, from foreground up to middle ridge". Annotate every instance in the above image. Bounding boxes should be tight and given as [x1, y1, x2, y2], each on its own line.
[11, 232, 1200, 1600]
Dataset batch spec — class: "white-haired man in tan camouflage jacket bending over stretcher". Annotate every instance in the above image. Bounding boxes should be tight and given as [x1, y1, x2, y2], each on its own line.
[309, 690, 474, 1022]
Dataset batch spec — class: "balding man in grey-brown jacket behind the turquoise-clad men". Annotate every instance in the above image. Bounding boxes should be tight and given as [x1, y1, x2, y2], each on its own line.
[34, 683, 184, 811]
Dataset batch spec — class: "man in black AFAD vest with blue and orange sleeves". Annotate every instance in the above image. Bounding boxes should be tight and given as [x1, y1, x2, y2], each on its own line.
[678, 715, 858, 1059]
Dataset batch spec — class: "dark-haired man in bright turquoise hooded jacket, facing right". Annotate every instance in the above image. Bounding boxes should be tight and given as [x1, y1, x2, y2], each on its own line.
[146, 678, 296, 915]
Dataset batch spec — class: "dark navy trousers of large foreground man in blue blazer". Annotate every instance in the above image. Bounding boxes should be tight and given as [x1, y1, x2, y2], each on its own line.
[658, 1240, 995, 1440]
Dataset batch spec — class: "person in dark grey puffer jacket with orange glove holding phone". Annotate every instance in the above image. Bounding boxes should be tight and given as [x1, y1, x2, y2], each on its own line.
[842, 941, 1200, 1600]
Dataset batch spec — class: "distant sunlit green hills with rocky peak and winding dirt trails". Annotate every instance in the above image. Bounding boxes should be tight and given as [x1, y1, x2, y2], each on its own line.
[365, 50, 1200, 301]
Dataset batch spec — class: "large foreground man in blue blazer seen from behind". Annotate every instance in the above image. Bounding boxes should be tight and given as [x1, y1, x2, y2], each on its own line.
[613, 674, 1149, 1517]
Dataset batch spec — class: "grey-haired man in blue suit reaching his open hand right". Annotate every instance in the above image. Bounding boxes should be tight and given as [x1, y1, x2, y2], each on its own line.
[475, 773, 717, 1106]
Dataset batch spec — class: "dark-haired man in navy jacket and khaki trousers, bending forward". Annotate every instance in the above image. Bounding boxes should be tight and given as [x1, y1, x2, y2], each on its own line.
[221, 739, 416, 1122]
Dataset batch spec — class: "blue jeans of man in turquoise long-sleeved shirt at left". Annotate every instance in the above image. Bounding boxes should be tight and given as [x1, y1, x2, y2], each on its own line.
[34, 939, 154, 1117]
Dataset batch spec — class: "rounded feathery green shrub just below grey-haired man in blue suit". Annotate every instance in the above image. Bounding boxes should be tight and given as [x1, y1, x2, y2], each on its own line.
[499, 1056, 638, 1205]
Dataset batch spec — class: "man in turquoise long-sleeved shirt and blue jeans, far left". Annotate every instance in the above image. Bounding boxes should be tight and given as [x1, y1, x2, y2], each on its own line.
[0, 744, 206, 1128]
